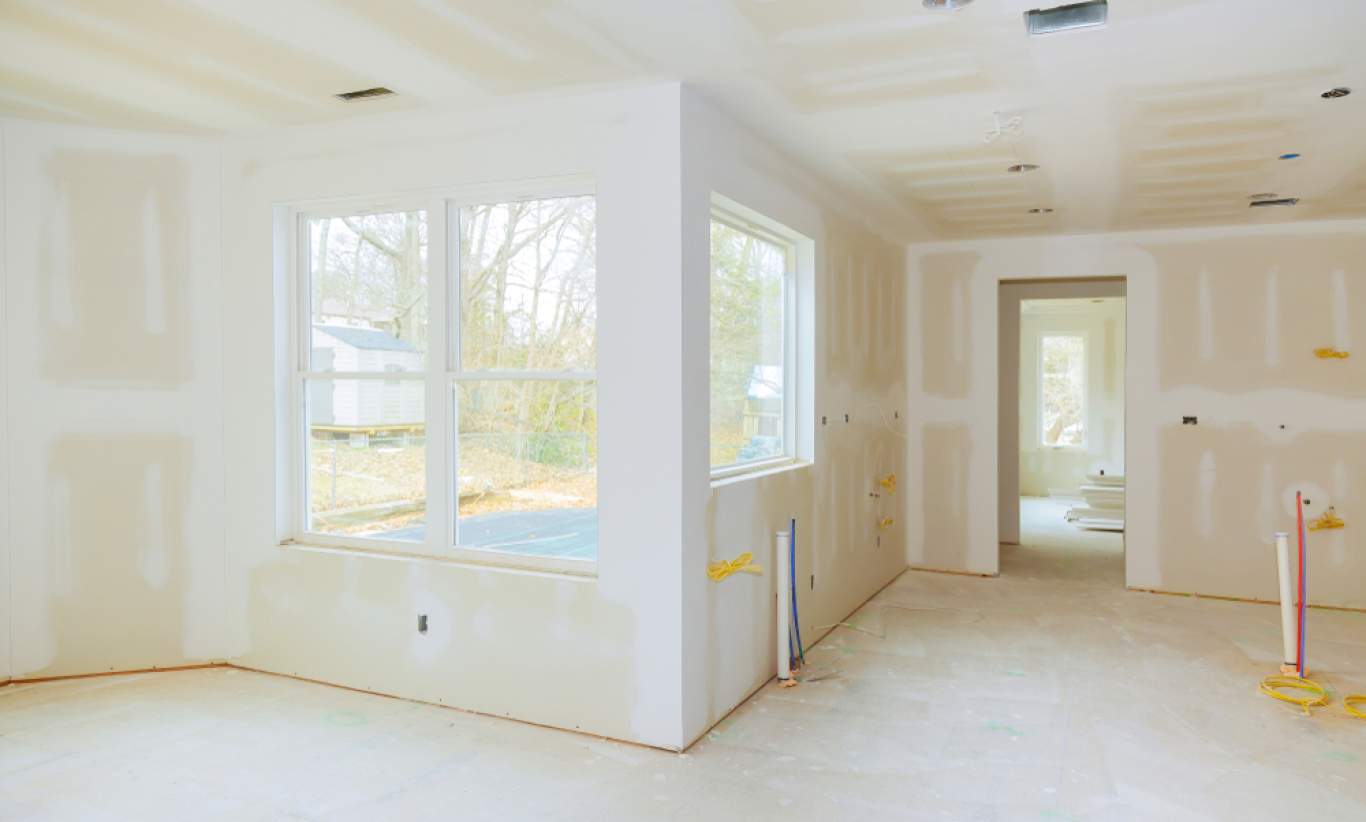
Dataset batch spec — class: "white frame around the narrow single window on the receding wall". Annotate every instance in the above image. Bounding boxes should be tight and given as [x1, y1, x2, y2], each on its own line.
[706, 203, 803, 482]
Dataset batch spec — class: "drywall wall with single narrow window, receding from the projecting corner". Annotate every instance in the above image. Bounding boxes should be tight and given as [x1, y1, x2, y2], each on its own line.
[683, 87, 906, 739]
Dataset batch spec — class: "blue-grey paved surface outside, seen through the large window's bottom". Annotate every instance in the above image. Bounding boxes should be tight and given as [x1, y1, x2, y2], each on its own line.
[373, 508, 597, 560]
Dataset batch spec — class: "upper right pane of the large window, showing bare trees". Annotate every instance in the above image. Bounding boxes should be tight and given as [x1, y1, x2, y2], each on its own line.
[460, 197, 597, 371]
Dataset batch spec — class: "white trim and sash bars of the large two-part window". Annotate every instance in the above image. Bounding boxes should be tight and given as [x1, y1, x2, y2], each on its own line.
[277, 176, 598, 578]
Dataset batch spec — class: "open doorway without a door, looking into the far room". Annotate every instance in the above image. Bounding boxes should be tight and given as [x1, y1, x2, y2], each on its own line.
[999, 277, 1128, 586]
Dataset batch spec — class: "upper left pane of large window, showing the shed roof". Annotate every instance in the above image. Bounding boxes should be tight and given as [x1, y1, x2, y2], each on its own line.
[309, 212, 428, 371]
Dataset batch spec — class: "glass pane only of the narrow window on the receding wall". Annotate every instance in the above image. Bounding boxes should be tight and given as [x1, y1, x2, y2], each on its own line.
[712, 221, 787, 467]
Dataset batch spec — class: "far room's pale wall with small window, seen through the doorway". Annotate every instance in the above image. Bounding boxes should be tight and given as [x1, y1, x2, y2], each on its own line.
[1021, 297, 1124, 497]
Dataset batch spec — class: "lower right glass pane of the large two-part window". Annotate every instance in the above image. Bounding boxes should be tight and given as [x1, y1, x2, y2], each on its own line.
[456, 380, 597, 560]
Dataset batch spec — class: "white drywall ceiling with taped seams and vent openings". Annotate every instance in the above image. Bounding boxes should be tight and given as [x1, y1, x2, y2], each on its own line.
[0, 0, 1366, 240]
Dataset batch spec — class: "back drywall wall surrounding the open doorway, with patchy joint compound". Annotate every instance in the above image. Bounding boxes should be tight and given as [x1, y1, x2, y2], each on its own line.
[907, 221, 1366, 606]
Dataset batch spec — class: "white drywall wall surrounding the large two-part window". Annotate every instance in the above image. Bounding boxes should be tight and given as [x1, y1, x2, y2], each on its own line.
[224, 85, 701, 748]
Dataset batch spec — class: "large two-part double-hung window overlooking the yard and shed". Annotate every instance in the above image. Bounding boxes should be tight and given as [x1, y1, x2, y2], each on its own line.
[292, 191, 597, 572]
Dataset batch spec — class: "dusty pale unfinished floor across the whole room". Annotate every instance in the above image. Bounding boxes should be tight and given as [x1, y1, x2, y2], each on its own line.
[0, 540, 1366, 822]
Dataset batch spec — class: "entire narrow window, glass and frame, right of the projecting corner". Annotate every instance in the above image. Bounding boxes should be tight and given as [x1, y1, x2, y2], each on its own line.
[710, 208, 796, 478]
